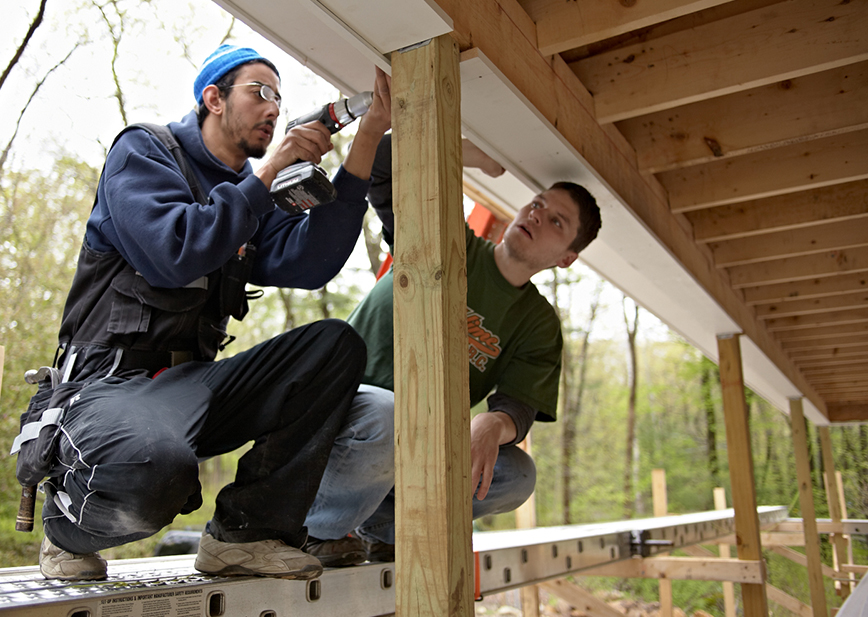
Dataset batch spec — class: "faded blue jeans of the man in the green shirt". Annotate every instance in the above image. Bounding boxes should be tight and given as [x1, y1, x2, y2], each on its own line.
[305, 385, 536, 544]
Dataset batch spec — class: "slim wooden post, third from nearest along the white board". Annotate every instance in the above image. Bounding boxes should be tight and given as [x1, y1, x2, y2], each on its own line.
[790, 398, 828, 617]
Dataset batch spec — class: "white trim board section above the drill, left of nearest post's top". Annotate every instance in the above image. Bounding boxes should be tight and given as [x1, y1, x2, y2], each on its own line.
[214, 0, 452, 95]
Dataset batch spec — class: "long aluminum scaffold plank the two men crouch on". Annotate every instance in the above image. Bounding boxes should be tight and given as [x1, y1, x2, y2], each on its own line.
[0, 506, 787, 617]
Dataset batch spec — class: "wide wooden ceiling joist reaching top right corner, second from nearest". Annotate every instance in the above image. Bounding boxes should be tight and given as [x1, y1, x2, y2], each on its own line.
[570, 0, 868, 123]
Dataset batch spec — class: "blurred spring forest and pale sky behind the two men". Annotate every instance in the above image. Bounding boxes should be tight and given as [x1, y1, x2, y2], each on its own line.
[0, 0, 868, 615]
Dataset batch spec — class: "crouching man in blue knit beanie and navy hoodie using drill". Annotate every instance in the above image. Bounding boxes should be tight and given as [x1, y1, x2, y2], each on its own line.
[22, 45, 391, 580]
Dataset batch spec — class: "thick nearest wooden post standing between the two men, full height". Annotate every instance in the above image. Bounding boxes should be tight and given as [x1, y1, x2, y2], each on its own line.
[392, 35, 474, 617]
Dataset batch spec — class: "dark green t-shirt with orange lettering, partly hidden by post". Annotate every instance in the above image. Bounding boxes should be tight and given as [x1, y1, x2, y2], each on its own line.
[347, 228, 563, 421]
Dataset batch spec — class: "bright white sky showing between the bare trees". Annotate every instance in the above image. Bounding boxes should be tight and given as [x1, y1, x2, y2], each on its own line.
[0, 0, 667, 346]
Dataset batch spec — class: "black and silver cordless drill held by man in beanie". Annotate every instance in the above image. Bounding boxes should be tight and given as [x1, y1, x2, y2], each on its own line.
[271, 92, 374, 214]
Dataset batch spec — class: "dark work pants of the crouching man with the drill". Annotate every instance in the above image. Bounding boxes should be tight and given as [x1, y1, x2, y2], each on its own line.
[43, 320, 366, 553]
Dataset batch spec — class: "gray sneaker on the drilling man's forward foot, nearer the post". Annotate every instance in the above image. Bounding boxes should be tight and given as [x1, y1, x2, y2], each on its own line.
[195, 531, 322, 580]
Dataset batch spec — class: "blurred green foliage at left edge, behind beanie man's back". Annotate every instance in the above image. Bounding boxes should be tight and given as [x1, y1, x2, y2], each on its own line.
[0, 155, 97, 564]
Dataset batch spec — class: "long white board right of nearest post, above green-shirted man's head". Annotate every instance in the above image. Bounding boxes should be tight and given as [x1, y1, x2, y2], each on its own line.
[461, 53, 828, 424]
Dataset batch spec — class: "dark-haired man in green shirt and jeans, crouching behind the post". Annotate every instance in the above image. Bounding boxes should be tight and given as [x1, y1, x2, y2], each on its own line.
[305, 134, 601, 566]
